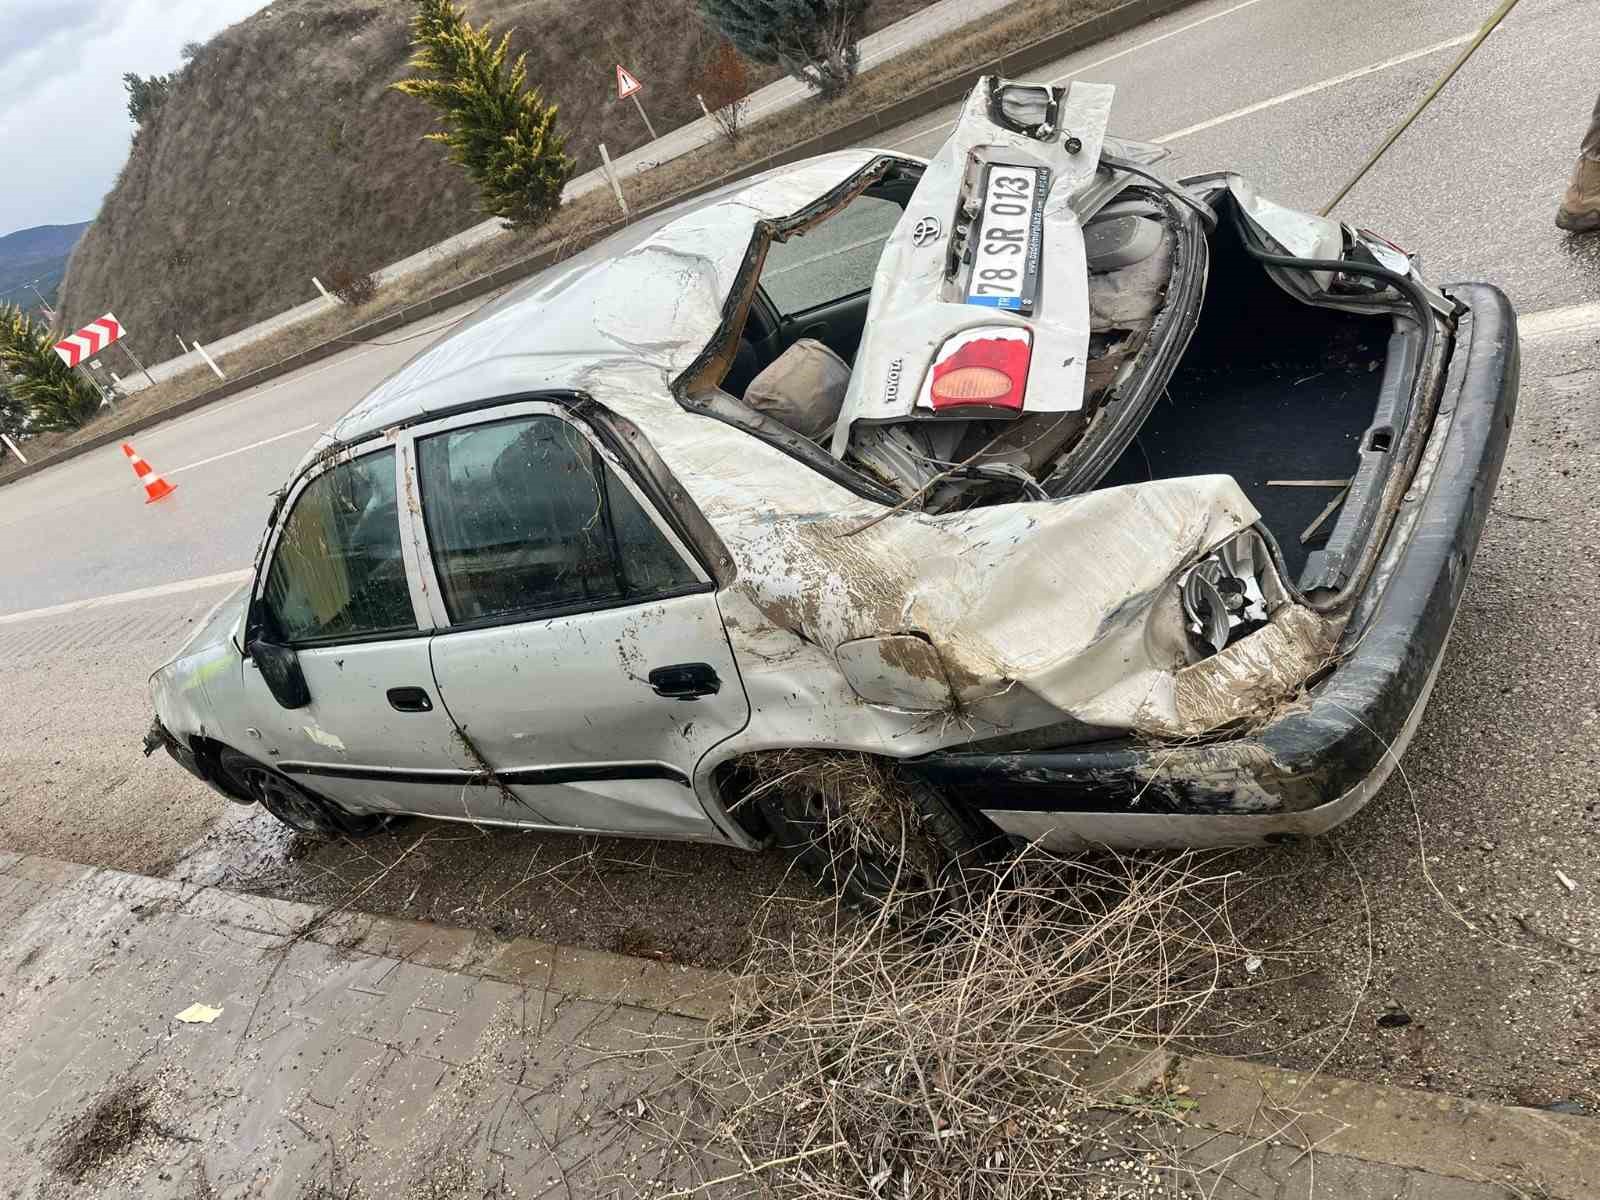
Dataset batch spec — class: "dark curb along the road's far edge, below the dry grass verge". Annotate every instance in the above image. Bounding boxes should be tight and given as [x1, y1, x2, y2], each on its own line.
[0, 0, 1194, 488]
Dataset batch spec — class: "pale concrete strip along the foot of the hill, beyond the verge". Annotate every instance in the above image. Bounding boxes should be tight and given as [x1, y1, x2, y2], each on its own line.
[120, 0, 1013, 392]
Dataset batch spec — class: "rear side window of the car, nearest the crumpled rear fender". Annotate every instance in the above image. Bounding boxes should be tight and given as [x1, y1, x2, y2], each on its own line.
[416, 414, 698, 624]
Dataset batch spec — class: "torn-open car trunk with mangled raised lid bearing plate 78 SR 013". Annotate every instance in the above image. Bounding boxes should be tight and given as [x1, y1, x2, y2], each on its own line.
[700, 78, 1453, 620]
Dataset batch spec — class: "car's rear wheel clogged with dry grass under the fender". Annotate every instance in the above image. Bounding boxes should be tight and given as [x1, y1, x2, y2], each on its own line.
[754, 768, 1000, 910]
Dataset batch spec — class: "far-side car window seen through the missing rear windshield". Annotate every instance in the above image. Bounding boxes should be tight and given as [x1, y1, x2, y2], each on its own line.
[762, 195, 904, 317]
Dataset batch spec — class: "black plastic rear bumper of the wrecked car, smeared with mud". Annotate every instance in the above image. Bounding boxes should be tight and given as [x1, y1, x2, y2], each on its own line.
[907, 283, 1520, 816]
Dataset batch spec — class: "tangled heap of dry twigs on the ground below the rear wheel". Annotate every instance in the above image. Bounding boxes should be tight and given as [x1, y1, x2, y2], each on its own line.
[649, 850, 1248, 1200]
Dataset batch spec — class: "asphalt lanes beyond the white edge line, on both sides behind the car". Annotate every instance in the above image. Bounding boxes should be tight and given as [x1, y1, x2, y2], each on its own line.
[0, 0, 1600, 613]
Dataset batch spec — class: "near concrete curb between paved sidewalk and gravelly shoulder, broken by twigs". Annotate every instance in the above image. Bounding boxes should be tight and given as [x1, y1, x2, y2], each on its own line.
[0, 853, 1600, 1200]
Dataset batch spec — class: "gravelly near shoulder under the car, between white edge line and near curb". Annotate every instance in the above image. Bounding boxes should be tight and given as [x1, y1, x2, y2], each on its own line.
[0, 338, 1600, 1114]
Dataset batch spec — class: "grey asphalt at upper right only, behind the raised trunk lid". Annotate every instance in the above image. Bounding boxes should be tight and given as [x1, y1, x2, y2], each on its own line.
[886, 0, 1600, 312]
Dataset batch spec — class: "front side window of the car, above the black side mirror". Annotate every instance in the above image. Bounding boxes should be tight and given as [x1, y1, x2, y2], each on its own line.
[262, 446, 416, 643]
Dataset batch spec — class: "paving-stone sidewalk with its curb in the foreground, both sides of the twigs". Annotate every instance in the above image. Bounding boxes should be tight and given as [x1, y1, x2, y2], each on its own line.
[0, 853, 1600, 1200]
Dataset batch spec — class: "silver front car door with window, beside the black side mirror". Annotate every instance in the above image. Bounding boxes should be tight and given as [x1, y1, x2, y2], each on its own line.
[238, 438, 466, 811]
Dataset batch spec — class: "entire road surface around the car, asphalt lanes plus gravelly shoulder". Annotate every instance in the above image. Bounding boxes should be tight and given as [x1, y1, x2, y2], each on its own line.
[0, 0, 1600, 1110]
